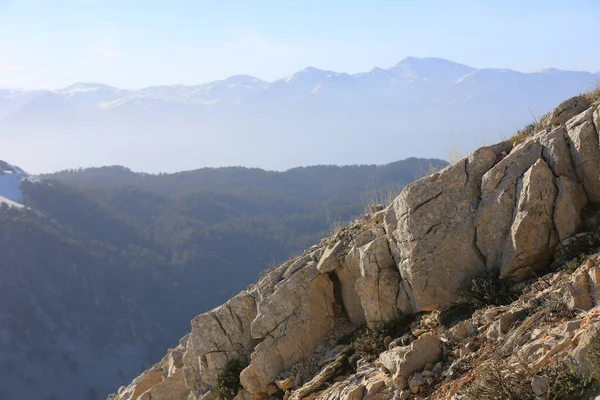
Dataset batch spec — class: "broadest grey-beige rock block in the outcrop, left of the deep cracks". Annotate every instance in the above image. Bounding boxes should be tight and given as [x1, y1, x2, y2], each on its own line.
[385, 147, 499, 311]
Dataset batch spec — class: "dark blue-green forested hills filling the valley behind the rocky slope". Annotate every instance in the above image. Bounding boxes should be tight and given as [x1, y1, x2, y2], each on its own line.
[0, 159, 447, 399]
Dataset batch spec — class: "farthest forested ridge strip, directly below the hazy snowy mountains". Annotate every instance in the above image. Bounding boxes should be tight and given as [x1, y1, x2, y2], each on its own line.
[42, 158, 440, 201]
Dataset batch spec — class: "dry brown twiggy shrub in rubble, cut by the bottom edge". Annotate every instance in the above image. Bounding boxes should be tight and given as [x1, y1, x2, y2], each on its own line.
[461, 360, 535, 400]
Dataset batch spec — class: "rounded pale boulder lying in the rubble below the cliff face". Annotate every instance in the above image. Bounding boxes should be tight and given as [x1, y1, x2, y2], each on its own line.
[379, 334, 442, 377]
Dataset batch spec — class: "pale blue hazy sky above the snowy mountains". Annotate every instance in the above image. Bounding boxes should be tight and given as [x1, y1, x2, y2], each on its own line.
[0, 0, 600, 88]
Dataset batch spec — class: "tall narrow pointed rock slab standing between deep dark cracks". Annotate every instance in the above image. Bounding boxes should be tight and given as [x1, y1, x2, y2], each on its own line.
[500, 159, 557, 278]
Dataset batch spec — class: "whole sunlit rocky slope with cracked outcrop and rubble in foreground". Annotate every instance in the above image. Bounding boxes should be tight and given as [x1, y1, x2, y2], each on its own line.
[115, 92, 600, 400]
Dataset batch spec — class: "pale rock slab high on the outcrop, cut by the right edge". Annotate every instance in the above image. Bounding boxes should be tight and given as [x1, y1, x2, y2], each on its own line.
[567, 108, 600, 203]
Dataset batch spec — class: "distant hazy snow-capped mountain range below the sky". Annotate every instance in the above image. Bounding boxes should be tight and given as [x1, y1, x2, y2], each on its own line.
[0, 57, 600, 172]
